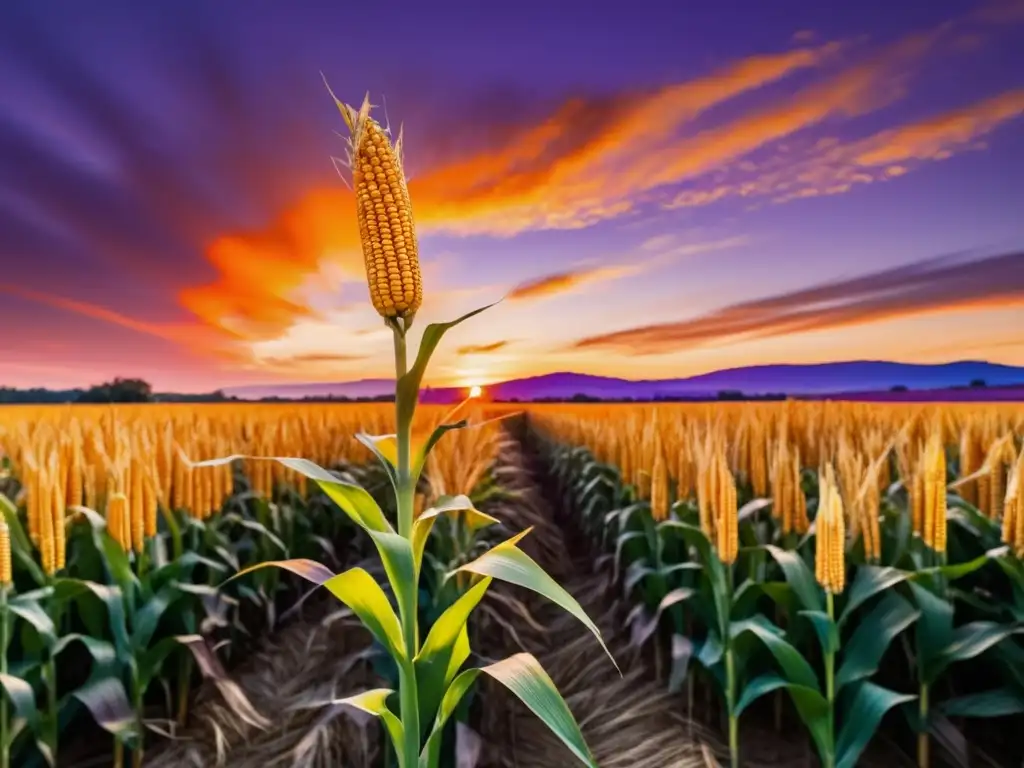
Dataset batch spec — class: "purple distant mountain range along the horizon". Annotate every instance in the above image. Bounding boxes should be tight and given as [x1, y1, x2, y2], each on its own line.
[224, 360, 1024, 402]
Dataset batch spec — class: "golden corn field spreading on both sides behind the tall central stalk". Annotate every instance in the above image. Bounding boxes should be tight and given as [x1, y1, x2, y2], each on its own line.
[0, 402, 1024, 768]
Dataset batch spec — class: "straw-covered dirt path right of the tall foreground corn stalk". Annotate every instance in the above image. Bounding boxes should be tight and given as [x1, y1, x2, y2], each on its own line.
[480, 440, 723, 768]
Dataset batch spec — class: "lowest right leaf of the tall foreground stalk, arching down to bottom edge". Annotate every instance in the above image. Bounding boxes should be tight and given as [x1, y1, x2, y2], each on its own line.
[420, 653, 599, 768]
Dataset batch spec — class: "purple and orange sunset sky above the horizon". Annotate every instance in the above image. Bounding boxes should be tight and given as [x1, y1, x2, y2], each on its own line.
[0, 0, 1024, 391]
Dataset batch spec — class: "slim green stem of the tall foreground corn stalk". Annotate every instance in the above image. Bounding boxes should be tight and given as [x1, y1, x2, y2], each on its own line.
[392, 321, 420, 768]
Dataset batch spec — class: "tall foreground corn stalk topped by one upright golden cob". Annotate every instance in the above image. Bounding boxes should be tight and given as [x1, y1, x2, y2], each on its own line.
[189, 94, 614, 768]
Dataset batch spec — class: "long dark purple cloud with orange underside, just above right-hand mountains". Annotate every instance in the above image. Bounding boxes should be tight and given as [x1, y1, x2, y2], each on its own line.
[573, 252, 1024, 354]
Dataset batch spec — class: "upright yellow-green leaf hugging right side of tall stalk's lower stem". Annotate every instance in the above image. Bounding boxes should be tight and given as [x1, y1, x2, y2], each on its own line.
[415, 577, 492, 727]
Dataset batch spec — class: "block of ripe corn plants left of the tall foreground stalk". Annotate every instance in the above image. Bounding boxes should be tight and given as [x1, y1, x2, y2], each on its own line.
[0, 406, 411, 768]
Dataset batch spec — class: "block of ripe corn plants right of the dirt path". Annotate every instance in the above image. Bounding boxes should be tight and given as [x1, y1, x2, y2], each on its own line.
[530, 402, 1024, 768]
